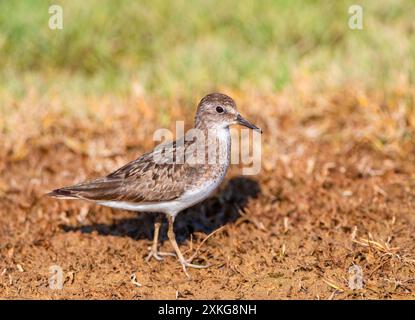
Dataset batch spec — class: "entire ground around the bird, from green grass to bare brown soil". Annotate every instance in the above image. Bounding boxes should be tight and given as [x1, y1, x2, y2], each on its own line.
[0, 0, 415, 299]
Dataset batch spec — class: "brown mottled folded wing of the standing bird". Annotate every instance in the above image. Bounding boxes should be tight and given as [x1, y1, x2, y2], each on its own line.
[51, 142, 200, 203]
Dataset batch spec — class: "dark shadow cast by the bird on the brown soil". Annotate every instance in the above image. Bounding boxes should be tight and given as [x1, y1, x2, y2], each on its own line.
[61, 177, 261, 243]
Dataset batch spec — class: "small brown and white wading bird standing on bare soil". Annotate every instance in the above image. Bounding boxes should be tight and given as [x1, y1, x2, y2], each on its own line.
[47, 93, 262, 278]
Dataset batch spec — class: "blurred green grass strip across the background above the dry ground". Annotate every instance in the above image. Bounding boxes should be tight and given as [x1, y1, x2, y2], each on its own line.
[0, 0, 415, 98]
